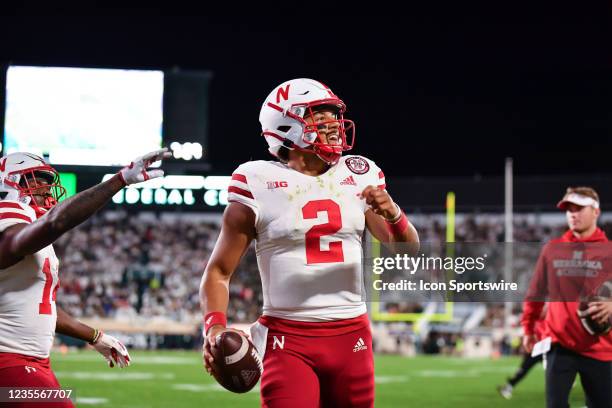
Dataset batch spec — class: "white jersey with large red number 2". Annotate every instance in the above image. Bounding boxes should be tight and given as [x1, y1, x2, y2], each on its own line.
[228, 156, 385, 321]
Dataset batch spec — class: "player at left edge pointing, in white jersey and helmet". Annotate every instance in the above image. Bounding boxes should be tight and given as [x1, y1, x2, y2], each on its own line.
[0, 149, 170, 406]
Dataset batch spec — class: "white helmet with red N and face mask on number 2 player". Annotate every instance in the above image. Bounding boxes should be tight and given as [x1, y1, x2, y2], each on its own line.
[259, 78, 355, 164]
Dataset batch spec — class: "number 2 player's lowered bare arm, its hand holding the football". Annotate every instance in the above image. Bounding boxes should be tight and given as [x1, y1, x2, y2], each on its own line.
[200, 202, 255, 373]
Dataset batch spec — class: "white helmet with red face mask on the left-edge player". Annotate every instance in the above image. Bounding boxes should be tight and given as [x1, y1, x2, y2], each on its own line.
[0, 153, 66, 216]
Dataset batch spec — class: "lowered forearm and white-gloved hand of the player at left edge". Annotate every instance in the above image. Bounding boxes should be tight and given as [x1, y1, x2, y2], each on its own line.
[55, 305, 130, 368]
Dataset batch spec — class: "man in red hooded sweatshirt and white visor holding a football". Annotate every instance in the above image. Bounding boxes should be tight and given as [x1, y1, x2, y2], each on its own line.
[521, 187, 612, 407]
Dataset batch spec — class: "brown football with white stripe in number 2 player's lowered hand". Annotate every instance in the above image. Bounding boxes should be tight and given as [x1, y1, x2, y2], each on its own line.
[212, 331, 263, 393]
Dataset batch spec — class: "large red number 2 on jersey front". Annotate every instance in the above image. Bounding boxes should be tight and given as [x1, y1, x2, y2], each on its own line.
[302, 199, 344, 264]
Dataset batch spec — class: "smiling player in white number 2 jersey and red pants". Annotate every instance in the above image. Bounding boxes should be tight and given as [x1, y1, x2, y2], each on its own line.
[200, 79, 419, 408]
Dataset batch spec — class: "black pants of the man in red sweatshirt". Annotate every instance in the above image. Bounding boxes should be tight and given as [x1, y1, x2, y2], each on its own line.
[546, 344, 612, 408]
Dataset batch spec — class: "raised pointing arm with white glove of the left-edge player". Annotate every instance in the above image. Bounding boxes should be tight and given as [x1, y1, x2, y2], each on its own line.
[0, 149, 171, 269]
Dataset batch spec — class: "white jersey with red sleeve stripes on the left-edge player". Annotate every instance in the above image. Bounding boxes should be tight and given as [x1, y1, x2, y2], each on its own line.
[0, 201, 59, 358]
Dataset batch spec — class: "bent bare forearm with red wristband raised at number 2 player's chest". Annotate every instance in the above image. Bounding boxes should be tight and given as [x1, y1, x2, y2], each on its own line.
[361, 186, 419, 253]
